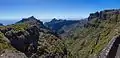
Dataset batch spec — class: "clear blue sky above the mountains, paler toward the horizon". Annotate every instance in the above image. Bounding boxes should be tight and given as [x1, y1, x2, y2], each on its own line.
[0, 0, 120, 20]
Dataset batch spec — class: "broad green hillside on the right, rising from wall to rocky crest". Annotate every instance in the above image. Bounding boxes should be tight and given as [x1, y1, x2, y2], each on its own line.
[60, 10, 120, 58]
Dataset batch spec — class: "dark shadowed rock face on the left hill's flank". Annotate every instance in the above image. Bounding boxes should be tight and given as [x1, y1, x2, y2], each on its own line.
[0, 26, 39, 54]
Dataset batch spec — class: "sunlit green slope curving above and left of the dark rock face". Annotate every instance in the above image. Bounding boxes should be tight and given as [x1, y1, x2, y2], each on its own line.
[0, 24, 27, 54]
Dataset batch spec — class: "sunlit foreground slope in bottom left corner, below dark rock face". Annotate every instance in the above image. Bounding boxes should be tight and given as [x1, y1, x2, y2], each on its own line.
[0, 26, 27, 58]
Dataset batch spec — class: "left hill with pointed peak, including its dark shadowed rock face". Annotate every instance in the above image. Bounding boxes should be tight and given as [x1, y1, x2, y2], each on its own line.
[0, 16, 64, 58]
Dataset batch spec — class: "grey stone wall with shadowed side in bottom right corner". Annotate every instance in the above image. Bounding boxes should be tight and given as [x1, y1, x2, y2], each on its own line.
[98, 35, 120, 58]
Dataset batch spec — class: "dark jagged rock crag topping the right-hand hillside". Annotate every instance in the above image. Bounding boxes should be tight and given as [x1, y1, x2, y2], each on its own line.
[88, 9, 120, 20]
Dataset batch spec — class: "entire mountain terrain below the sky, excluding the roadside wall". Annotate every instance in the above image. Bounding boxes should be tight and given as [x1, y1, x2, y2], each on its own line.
[0, 9, 120, 58]
